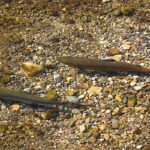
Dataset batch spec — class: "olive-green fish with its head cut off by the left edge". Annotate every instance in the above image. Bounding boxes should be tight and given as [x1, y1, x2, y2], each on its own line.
[0, 87, 90, 107]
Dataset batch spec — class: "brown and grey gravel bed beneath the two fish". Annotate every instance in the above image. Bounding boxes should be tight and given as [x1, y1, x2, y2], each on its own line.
[0, 0, 150, 150]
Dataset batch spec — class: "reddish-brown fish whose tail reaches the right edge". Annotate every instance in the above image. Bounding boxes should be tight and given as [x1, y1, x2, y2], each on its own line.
[57, 56, 150, 75]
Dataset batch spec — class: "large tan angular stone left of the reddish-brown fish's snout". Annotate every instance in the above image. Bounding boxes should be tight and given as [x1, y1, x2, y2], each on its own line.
[21, 62, 42, 77]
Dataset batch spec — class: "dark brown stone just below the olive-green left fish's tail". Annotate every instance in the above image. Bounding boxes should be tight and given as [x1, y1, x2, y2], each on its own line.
[41, 108, 58, 120]
